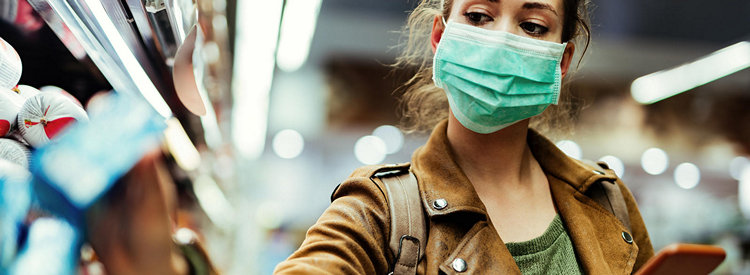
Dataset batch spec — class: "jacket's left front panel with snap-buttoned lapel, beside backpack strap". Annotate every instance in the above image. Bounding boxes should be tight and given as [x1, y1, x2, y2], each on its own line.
[411, 121, 506, 274]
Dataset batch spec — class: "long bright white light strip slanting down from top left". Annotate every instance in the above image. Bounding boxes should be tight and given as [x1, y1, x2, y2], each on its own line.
[85, 0, 172, 119]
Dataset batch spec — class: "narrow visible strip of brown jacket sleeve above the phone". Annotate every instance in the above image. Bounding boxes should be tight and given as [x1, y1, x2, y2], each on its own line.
[617, 180, 654, 273]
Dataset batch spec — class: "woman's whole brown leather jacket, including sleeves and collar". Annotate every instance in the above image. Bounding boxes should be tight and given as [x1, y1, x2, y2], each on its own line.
[275, 122, 654, 274]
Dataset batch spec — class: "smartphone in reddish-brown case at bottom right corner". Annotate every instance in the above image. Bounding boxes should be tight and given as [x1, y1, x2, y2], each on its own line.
[636, 244, 726, 275]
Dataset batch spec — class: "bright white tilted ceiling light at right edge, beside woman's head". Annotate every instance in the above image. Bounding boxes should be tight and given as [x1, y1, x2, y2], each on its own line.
[630, 41, 750, 104]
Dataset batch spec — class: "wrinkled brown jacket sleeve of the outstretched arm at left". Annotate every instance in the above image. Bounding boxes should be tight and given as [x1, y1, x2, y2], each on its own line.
[274, 177, 392, 274]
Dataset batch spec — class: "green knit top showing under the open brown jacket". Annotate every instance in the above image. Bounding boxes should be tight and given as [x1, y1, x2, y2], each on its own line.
[505, 215, 583, 275]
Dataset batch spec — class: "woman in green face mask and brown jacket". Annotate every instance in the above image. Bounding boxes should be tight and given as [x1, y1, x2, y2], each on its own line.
[276, 0, 653, 274]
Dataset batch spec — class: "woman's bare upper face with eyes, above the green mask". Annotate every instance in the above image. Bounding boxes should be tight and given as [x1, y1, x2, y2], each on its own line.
[446, 0, 563, 43]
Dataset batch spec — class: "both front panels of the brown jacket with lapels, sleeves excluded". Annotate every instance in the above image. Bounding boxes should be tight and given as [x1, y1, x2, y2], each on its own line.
[411, 121, 638, 274]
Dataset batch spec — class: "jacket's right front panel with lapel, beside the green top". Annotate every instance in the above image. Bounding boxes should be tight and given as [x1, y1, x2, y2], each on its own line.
[528, 130, 638, 274]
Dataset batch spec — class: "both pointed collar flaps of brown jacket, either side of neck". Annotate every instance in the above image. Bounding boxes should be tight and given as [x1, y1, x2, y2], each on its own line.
[412, 120, 616, 217]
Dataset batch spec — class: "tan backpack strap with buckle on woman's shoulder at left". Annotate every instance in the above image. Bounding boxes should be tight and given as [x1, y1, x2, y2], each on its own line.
[373, 166, 427, 275]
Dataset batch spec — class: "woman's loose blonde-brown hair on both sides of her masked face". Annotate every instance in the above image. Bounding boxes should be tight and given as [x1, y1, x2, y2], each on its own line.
[391, 0, 591, 135]
